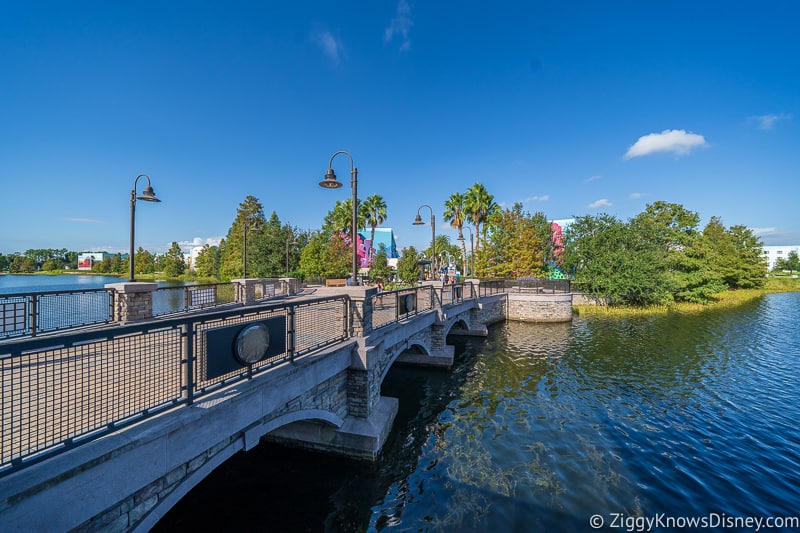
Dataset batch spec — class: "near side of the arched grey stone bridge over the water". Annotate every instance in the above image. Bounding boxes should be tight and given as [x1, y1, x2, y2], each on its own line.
[0, 284, 571, 531]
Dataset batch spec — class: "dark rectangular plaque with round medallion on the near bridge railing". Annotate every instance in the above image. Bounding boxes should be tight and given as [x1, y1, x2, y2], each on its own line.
[206, 316, 286, 379]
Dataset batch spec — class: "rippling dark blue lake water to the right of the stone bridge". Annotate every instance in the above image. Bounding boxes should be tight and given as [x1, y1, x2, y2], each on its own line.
[156, 293, 800, 532]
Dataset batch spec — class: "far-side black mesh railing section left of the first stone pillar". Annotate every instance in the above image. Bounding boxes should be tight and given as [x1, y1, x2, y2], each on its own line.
[0, 289, 114, 340]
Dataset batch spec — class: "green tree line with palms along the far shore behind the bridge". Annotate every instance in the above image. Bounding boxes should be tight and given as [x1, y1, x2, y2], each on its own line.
[0, 186, 776, 305]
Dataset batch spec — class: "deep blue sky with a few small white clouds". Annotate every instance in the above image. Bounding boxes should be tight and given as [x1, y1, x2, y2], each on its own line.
[0, 0, 800, 253]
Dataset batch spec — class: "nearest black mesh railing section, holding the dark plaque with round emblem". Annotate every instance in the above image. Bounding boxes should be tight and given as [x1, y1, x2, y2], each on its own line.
[0, 295, 349, 477]
